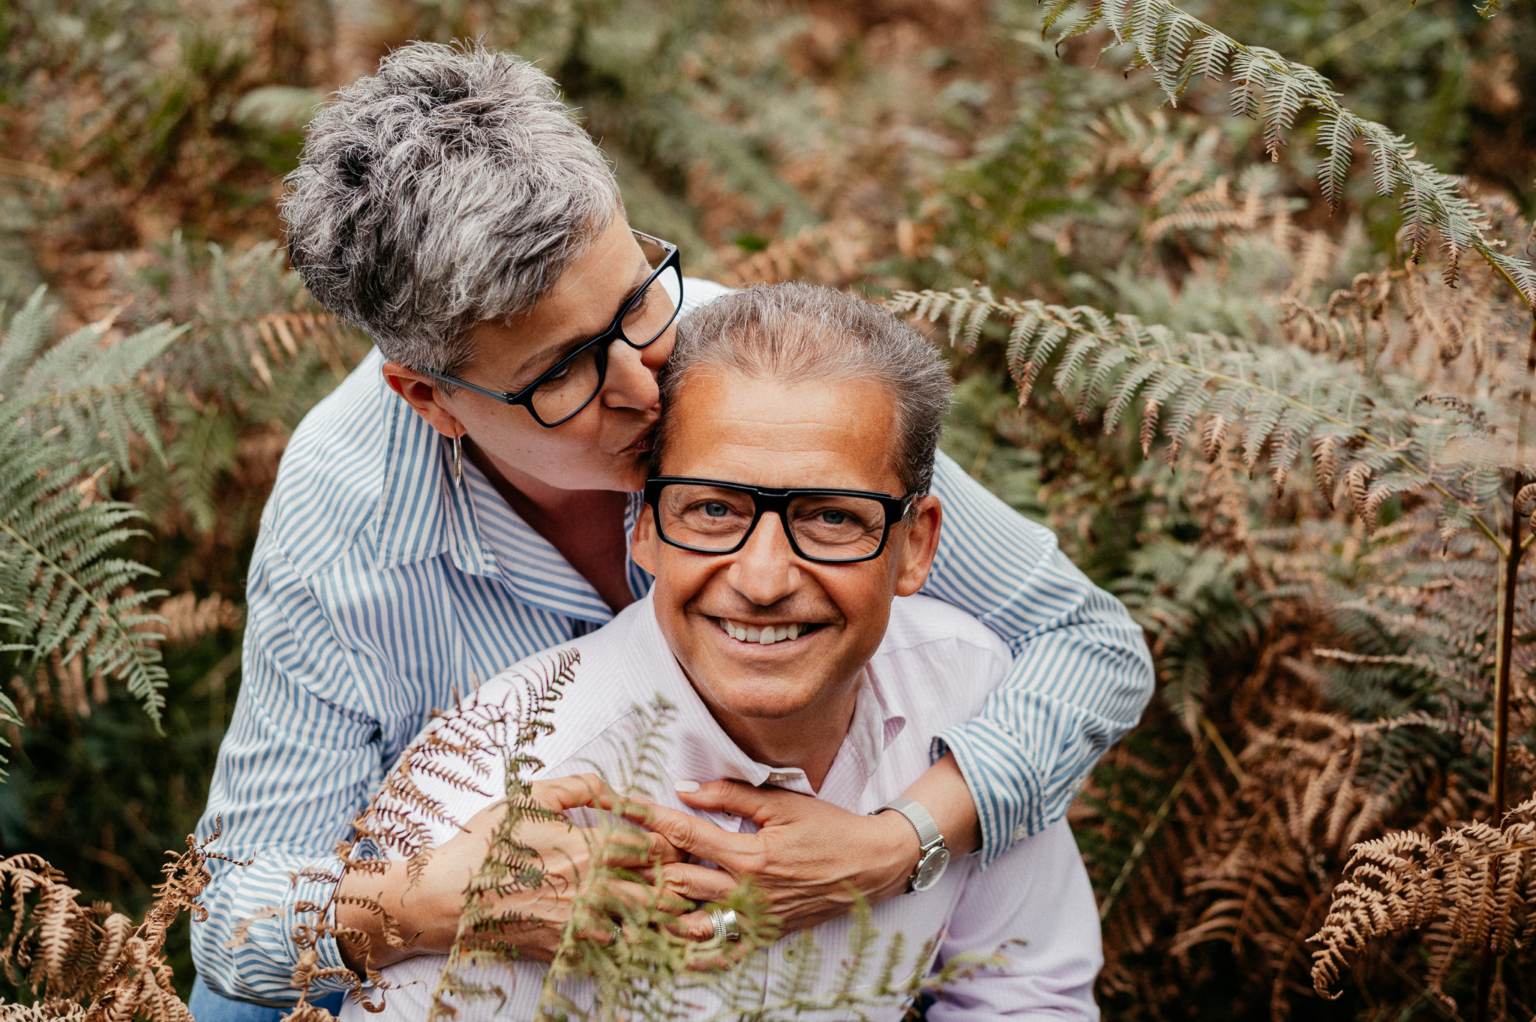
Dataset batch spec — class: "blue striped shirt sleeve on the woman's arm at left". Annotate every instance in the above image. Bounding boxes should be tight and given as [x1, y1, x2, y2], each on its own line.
[192, 550, 381, 1005]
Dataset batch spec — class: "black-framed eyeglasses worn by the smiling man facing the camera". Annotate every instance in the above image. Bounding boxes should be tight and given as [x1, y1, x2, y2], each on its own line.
[645, 475, 917, 564]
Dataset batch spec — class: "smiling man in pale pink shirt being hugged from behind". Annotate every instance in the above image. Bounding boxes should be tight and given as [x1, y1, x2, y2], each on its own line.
[343, 284, 1101, 1022]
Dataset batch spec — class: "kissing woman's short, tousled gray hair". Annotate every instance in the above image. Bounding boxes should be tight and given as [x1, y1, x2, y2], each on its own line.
[283, 43, 622, 373]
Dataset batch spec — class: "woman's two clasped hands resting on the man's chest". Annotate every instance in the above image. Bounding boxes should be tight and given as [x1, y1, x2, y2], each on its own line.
[336, 775, 919, 971]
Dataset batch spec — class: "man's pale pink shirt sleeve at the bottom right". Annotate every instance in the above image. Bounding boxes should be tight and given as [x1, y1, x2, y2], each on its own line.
[926, 821, 1104, 1022]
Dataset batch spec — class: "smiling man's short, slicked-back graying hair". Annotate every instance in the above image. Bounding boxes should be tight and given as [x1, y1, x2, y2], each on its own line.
[654, 283, 954, 493]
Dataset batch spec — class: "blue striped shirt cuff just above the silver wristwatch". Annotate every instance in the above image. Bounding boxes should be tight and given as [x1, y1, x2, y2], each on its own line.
[929, 718, 1044, 870]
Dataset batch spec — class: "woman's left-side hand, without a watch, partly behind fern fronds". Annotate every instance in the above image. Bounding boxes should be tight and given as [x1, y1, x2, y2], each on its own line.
[336, 775, 691, 973]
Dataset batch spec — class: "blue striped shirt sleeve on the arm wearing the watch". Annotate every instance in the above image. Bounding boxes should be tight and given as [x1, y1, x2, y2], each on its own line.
[923, 453, 1152, 867]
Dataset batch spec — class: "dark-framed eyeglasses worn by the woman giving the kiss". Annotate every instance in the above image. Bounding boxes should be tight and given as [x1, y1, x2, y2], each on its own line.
[421, 231, 682, 429]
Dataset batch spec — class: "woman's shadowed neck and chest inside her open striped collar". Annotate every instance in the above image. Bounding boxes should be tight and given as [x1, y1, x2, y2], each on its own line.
[464, 443, 634, 612]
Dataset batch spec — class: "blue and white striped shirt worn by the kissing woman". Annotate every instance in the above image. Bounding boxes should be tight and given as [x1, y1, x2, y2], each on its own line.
[192, 281, 1152, 1004]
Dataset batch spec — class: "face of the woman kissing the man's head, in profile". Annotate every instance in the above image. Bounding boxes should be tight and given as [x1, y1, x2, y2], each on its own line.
[384, 217, 677, 492]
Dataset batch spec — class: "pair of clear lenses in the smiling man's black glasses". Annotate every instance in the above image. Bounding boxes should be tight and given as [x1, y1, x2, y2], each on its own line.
[656, 483, 885, 561]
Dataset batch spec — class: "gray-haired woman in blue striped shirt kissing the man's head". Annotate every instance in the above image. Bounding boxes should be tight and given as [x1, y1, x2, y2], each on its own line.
[192, 43, 1152, 1022]
